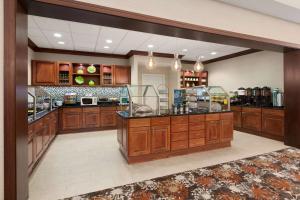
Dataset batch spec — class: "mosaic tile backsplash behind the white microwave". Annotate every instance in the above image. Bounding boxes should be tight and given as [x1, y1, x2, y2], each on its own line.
[42, 86, 122, 101]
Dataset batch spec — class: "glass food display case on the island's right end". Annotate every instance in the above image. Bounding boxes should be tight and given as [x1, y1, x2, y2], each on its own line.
[184, 86, 230, 112]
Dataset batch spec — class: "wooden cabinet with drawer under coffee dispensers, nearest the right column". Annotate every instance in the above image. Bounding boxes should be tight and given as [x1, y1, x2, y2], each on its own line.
[262, 109, 284, 139]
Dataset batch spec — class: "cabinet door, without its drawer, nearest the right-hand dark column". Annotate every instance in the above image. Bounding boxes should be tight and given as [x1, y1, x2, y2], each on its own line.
[262, 115, 284, 136]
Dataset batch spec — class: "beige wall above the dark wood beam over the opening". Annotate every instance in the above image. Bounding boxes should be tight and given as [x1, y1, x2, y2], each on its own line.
[78, 0, 300, 44]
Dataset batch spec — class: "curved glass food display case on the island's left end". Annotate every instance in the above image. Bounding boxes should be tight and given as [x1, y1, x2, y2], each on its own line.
[121, 85, 160, 116]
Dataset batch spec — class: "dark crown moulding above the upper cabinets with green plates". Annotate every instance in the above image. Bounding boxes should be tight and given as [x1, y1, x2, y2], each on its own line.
[34, 47, 128, 59]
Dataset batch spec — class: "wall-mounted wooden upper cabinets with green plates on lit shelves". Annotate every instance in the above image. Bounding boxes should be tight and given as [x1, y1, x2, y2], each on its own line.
[31, 60, 131, 86]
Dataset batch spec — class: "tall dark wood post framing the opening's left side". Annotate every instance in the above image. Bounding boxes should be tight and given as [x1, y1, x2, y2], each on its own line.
[3, 0, 28, 200]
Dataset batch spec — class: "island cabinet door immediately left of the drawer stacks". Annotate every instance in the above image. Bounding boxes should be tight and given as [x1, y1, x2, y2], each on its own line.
[151, 126, 170, 153]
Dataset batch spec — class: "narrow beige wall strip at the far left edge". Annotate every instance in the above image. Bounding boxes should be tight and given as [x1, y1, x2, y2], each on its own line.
[0, 0, 4, 199]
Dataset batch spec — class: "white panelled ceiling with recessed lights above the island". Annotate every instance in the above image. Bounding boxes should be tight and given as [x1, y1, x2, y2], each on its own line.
[28, 15, 247, 61]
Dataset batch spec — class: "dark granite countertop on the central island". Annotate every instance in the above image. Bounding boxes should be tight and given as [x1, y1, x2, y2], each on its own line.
[117, 111, 232, 119]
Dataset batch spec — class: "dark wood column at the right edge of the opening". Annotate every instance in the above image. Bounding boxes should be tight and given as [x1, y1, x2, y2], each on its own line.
[284, 50, 300, 148]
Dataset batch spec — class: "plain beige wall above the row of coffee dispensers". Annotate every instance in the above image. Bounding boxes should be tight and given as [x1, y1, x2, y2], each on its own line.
[205, 51, 283, 91]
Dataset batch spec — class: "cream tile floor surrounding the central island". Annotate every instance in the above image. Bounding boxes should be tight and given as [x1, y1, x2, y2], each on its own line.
[29, 131, 286, 200]
